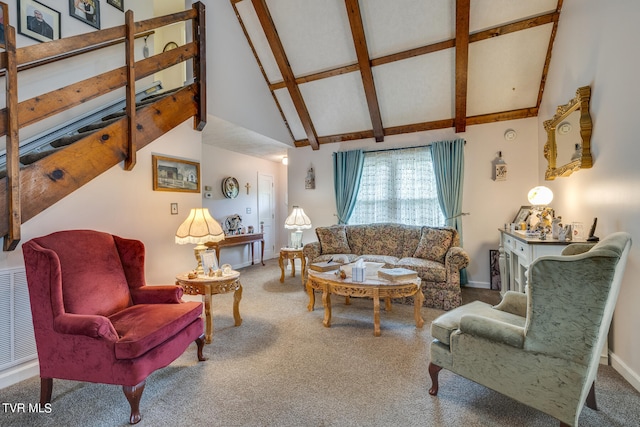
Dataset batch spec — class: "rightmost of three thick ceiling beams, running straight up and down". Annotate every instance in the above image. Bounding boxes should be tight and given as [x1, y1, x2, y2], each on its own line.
[455, 0, 471, 132]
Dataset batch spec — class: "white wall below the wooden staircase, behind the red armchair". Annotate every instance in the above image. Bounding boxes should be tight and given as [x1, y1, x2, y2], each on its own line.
[0, 120, 201, 284]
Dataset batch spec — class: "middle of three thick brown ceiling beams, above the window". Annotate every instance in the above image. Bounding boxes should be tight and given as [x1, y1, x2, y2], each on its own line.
[345, 0, 384, 142]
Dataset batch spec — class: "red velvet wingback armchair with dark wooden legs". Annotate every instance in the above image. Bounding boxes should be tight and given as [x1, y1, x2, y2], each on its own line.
[22, 230, 205, 424]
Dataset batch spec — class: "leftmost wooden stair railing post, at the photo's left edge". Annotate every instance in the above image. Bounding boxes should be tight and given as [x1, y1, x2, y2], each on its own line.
[3, 25, 22, 251]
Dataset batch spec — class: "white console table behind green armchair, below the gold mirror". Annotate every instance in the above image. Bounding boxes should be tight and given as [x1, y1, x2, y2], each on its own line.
[498, 228, 609, 365]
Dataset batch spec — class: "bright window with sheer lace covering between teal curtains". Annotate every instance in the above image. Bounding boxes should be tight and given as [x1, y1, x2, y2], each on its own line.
[349, 147, 445, 226]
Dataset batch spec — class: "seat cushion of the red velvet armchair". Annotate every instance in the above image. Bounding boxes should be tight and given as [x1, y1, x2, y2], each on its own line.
[109, 301, 202, 359]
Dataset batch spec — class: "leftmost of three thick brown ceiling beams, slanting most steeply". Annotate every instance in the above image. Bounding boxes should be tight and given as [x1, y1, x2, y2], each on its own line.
[251, 0, 320, 150]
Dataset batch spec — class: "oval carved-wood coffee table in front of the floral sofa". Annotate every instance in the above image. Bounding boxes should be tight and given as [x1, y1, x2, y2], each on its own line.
[306, 270, 424, 337]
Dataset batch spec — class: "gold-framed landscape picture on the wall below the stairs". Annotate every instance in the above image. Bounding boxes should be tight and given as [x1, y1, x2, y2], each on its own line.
[152, 155, 200, 193]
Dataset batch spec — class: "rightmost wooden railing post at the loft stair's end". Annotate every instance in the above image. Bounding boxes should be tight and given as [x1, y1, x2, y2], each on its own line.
[193, 2, 207, 131]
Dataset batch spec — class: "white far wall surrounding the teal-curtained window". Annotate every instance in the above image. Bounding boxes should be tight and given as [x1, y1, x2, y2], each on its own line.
[288, 118, 538, 288]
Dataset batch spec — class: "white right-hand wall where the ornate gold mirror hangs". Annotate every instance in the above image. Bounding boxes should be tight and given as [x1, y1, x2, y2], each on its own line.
[538, 0, 640, 389]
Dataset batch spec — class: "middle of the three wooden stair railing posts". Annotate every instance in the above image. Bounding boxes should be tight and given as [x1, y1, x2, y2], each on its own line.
[124, 9, 137, 171]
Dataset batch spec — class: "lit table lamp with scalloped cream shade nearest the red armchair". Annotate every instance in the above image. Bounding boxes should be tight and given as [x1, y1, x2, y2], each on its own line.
[176, 208, 224, 275]
